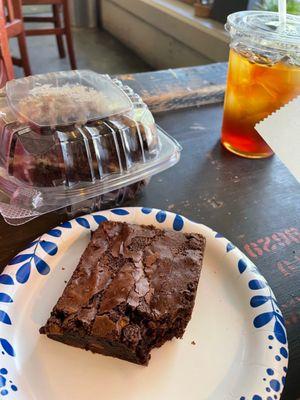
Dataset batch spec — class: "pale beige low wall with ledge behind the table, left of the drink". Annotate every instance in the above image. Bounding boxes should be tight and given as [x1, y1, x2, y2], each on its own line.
[101, 0, 229, 69]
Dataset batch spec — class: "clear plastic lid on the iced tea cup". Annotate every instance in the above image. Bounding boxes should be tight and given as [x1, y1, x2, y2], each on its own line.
[226, 11, 300, 52]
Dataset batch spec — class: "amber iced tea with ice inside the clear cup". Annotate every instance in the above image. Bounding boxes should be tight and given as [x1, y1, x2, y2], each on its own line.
[222, 49, 300, 158]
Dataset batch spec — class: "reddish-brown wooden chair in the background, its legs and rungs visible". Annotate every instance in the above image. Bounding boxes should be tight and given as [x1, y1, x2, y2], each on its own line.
[22, 0, 77, 69]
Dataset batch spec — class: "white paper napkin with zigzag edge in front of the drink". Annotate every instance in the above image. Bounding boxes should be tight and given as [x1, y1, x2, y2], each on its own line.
[255, 96, 300, 182]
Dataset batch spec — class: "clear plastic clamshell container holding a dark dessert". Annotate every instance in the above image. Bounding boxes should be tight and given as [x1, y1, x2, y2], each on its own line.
[0, 71, 181, 224]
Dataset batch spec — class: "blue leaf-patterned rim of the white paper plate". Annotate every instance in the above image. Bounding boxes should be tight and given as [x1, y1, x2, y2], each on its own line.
[0, 208, 288, 400]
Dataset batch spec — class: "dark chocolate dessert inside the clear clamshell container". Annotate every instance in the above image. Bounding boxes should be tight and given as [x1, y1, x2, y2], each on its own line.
[7, 116, 150, 217]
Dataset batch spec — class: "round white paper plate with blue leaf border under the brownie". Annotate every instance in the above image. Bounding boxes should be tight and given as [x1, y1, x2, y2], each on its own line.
[0, 208, 288, 400]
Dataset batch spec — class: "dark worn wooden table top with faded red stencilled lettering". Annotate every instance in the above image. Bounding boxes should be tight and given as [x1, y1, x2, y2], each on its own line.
[0, 64, 300, 400]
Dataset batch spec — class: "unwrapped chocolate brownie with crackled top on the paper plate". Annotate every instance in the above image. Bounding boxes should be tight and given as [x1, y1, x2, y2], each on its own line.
[40, 221, 205, 364]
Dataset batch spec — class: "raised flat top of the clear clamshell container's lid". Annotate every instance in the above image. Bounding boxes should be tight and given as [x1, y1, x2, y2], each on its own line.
[6, 71, 133, 127]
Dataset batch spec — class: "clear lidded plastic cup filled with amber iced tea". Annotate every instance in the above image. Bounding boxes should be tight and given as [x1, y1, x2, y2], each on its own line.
[221, 11, 300, 158]
